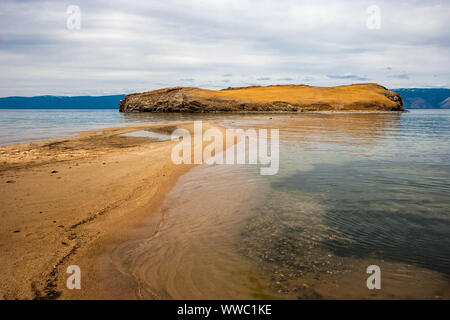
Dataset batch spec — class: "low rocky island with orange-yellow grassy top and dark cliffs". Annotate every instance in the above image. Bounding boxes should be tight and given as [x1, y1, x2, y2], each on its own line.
[119, 84, 404, 112]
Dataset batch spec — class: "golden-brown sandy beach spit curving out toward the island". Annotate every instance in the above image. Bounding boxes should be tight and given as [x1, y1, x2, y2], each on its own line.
[0, 123, 223, 299]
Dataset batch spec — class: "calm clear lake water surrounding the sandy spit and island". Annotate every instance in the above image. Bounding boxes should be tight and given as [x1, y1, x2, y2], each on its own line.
[0, 110, 450, 299]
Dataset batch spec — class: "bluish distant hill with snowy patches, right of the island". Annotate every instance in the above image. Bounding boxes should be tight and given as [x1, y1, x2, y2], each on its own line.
[392, 88, 450, 109]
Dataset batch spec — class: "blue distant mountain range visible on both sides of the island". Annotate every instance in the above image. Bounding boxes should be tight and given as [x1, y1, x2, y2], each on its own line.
[0, 88, 450, 109]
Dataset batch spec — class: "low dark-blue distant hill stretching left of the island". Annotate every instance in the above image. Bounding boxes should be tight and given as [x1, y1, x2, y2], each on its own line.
[0, 94, 125, 109]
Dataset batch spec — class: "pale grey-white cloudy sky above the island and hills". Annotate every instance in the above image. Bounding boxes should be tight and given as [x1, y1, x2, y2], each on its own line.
[0, 0, 450, 96]
